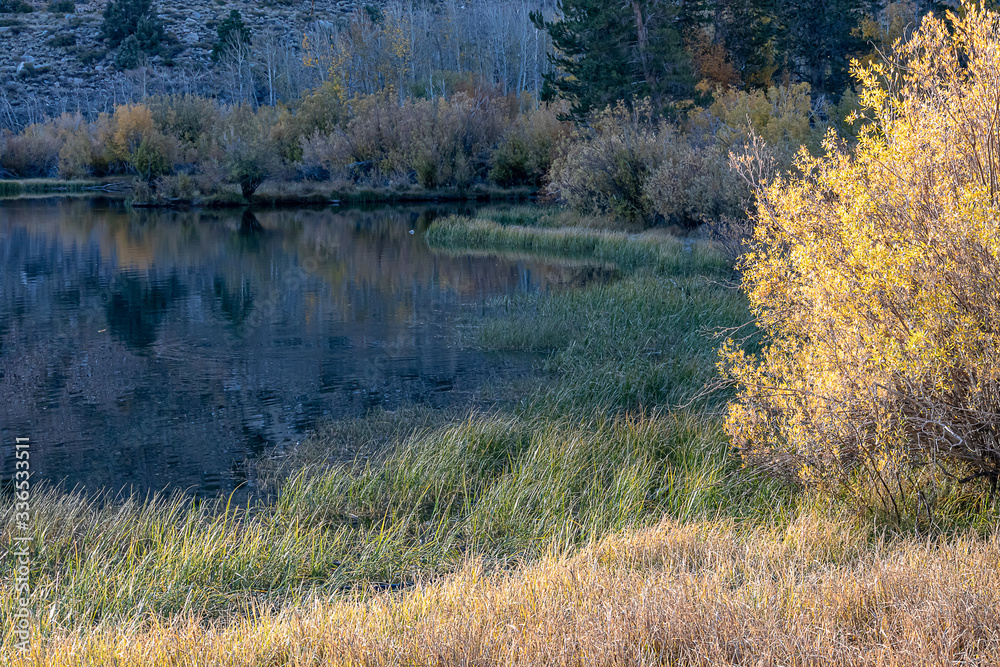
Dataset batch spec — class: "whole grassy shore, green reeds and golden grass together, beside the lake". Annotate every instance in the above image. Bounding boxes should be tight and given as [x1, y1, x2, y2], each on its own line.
[0, 210, 1000, 665]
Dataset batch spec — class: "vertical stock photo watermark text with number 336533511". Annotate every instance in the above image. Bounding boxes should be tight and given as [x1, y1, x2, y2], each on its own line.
[10, 438, 32, 653]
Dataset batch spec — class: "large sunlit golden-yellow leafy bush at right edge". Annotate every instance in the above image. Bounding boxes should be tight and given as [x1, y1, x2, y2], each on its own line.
[723, 3, 1000, 516]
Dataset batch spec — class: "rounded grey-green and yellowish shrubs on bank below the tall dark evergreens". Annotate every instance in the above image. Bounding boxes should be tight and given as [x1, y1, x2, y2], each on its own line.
[544, 84, 832, 227]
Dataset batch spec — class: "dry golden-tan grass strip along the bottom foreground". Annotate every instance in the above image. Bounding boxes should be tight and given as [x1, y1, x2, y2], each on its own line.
[9, 511, 1000, 667]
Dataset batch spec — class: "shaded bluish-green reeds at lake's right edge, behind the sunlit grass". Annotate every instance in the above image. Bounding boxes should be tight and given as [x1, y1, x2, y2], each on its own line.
[427, 209, 749, 413]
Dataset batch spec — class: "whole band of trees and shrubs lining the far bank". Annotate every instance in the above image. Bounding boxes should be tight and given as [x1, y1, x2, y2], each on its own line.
[0, 0, 943, 225]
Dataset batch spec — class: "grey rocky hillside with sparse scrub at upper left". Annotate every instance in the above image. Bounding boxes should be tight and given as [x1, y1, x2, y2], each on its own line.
[0, 0, 356, 127]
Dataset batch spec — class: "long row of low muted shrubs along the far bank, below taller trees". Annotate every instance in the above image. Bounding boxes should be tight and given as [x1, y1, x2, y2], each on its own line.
[0, 81, 817, 217]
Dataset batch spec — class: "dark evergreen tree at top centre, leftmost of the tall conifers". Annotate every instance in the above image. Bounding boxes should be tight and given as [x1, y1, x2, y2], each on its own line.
[532, 0, 694, 119]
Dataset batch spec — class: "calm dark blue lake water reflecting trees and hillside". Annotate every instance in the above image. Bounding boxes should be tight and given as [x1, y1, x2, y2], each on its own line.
[0, 198, 587, 494]
